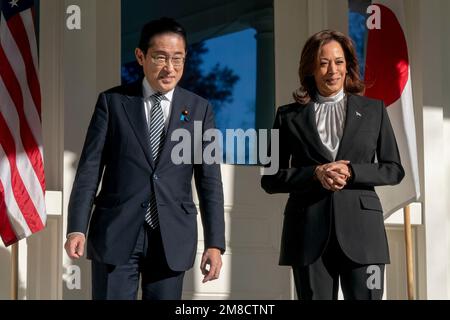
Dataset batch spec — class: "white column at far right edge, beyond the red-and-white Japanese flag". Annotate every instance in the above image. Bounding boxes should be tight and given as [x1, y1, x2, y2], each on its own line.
[419, 0, 450, 299]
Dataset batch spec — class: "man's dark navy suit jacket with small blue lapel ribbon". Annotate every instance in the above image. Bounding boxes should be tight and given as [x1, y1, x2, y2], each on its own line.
[67, 81, 225, 271]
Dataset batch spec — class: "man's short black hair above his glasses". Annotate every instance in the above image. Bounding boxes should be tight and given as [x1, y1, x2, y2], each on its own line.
[139, 17, 187, 54]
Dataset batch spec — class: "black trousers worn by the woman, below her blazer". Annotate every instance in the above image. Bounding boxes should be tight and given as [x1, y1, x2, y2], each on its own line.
[292, 215, 385, 300]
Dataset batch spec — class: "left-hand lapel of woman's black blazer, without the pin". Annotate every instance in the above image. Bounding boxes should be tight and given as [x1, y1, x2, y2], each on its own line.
[292, 101, 332, 163]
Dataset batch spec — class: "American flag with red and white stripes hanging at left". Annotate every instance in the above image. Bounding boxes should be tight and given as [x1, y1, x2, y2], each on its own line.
[0, 0, 46, 246]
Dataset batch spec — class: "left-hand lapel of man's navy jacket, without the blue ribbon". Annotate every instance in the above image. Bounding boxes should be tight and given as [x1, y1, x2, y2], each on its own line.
[122, 81, 155, 169]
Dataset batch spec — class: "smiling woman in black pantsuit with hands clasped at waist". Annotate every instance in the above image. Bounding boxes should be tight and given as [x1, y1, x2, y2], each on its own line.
[261, 30, 404, 300]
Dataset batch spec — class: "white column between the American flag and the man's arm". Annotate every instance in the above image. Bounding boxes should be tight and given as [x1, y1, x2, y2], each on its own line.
[61, 0, 121, 299]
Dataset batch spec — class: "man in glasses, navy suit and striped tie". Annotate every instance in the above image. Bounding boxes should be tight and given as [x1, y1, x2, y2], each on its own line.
[65, 18, 225, 299]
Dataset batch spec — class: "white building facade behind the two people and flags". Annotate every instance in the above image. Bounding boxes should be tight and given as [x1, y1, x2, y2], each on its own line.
[0, 0, 450, 299]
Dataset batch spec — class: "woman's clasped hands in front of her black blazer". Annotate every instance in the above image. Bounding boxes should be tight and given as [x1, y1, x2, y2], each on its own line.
[315, 160, 351, 191]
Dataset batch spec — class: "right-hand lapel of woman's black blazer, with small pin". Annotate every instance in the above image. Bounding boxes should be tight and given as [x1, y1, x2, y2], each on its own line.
[336, 94, 364, 161]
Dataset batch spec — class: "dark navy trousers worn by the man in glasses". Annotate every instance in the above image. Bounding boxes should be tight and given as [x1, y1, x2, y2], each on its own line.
[92, 223, 184, 300]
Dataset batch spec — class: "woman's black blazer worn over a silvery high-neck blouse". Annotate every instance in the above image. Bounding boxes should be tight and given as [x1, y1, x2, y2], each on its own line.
[261, 94, 405, 266]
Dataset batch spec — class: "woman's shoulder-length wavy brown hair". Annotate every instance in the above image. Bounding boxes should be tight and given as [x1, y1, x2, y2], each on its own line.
[293, 30, 365, 104]
